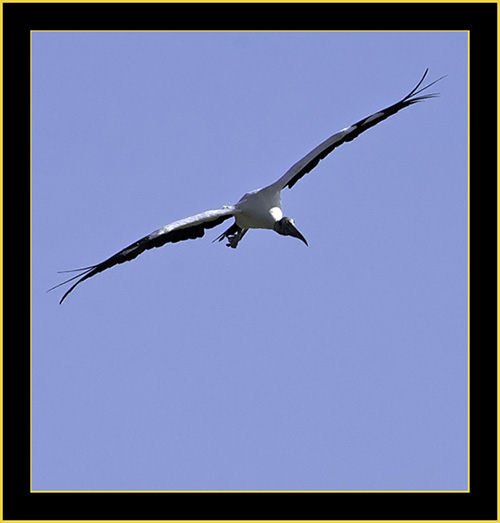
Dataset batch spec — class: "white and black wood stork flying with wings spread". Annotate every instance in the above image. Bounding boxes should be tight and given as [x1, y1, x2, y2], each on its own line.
[49, 69, 444, 303]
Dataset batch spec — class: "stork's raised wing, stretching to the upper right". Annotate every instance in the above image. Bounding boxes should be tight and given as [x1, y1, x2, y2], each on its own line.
[273, 69, 444, 189]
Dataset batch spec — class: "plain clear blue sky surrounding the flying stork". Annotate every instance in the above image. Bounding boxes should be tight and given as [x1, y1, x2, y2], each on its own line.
[32, 32, 468, 491]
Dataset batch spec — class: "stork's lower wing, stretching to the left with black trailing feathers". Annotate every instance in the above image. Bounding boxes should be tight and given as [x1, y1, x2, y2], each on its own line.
[49, 206, 235, 303]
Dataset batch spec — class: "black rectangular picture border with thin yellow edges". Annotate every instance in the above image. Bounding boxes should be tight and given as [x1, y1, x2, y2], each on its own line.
[2, 3, 498, 521]
